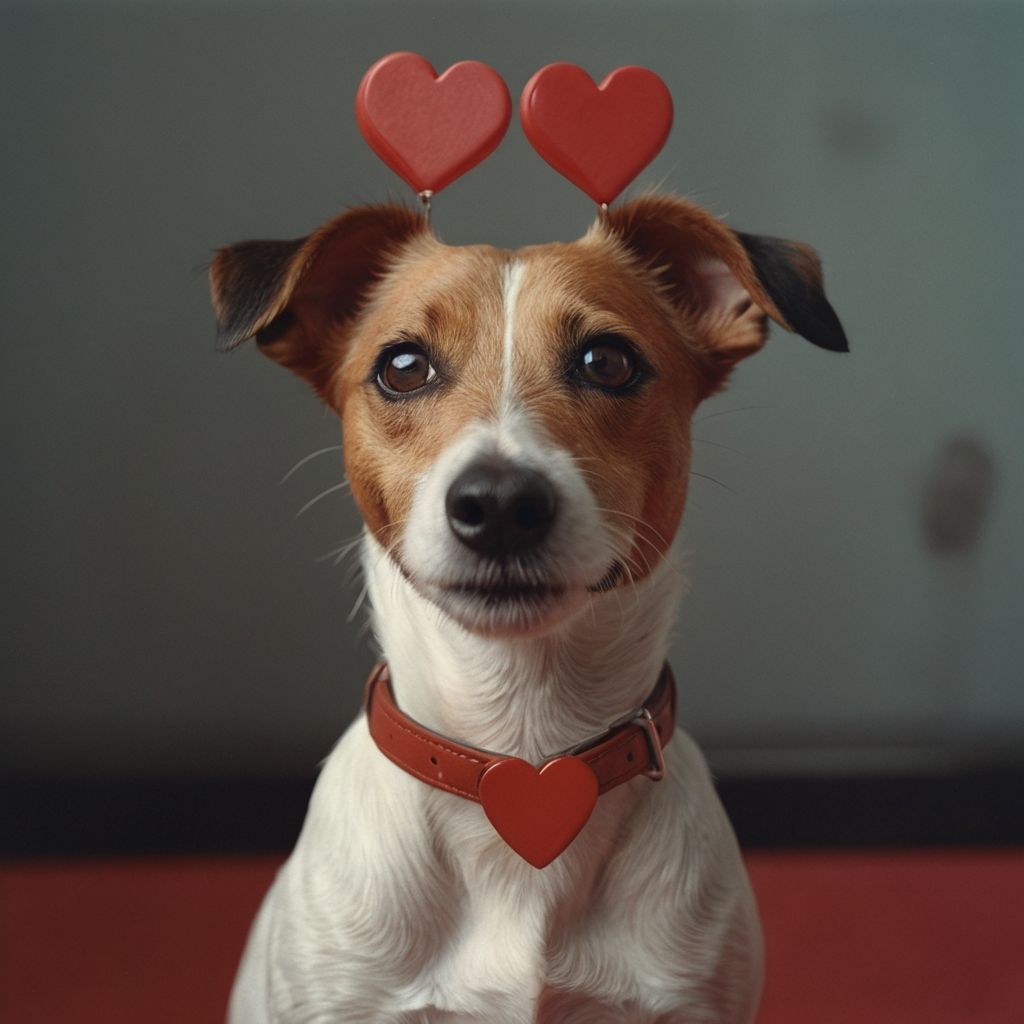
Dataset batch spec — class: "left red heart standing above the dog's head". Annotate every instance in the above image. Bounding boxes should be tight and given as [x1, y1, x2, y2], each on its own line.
[355, 53, 512, 193]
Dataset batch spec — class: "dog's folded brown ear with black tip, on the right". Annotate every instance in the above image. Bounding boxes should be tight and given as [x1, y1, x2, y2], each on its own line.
[605, 195, 849, 365]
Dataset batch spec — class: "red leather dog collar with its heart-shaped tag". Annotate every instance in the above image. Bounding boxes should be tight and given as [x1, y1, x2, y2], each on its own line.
[364, 662, 676, 867]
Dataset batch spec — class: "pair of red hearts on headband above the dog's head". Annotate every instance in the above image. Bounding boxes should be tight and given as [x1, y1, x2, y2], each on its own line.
[355, 53, 673, 214]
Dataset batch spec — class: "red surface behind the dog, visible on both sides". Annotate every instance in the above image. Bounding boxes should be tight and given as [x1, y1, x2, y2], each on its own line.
[0, 852, 1024, 1024]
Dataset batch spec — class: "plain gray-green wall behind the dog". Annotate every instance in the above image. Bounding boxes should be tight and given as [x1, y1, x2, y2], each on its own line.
[0, 0, 1024, 775]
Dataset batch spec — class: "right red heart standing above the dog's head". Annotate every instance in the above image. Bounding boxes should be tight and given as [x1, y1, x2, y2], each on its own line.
[519, 63, 672, 203]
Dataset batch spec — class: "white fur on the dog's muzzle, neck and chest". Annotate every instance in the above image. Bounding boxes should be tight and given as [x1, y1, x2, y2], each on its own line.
[230, 411, 761, 1024]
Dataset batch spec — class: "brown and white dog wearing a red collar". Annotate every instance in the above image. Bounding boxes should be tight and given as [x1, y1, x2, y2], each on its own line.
[211, 193, 847, 1024]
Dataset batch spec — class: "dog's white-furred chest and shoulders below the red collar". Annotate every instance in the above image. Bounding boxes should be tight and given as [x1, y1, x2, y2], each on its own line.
[239, 728, 759, 1024]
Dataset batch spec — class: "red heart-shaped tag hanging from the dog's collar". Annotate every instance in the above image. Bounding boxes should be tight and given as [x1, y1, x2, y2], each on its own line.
[479, 757, 597, 867]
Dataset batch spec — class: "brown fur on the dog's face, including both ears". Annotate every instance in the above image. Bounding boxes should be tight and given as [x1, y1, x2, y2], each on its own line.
[211, 195, 847, 589]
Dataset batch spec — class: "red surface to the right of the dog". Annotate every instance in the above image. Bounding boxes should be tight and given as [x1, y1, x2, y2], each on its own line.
[749, 852, 1024, 1024]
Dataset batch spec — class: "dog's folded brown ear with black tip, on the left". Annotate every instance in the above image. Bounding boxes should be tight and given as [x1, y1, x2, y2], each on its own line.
[210, 206, 428, 397]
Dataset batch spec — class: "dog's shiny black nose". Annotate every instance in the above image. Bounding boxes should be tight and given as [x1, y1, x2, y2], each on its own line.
[444, 457, 558, 558]
